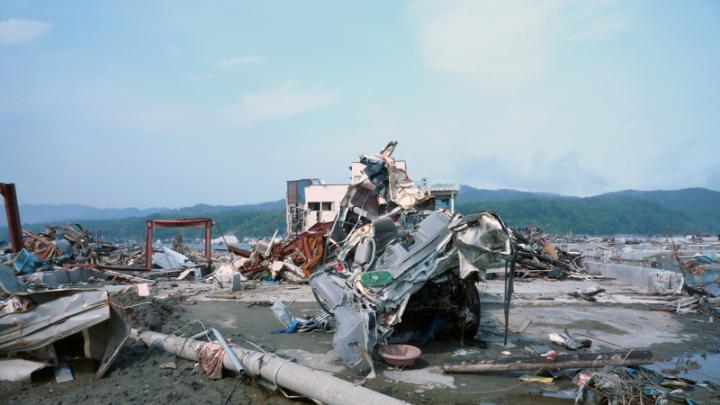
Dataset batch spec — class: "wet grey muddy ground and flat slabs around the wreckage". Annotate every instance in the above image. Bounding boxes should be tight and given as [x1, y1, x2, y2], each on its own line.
[0, 280, 720, 404]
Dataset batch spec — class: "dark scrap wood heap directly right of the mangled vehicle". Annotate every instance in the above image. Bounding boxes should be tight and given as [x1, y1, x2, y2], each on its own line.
[512, 225, 582, 279]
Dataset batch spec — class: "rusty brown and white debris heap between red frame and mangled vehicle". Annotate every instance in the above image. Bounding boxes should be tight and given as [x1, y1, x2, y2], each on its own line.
[228, 222, 332, 282]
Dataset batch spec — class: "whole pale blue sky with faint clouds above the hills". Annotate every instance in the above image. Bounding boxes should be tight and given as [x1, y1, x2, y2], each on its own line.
[0, 0, 720, 208]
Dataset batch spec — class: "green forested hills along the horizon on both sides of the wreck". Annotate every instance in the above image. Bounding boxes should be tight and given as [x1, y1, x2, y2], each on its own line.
[0, 186, 720, 240]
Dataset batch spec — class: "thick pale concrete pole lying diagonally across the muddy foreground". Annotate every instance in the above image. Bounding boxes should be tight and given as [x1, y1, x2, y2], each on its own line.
[130, 329, 407, 405]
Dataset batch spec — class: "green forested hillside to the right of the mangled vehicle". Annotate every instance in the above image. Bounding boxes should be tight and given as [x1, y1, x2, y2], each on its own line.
[458, 186, 720, 235]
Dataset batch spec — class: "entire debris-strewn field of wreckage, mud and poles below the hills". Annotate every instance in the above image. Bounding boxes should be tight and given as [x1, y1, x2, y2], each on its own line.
[0, 142, 720, 404]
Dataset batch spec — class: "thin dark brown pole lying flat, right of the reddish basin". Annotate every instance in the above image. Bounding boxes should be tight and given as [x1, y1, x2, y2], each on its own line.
[443, 350, 655, 374]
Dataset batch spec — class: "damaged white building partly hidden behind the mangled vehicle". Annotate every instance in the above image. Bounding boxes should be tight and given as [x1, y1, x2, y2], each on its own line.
[285, 160, 459, 235]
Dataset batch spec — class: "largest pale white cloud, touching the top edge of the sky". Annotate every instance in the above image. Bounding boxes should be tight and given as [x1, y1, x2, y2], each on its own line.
[410, 0, 629, 88]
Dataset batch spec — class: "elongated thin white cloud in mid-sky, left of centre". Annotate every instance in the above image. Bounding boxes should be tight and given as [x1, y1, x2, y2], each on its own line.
[225, 84, 340, 125]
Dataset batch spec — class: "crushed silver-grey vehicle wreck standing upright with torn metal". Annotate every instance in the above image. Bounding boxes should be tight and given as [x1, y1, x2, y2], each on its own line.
[310, 142, 513, 366]
